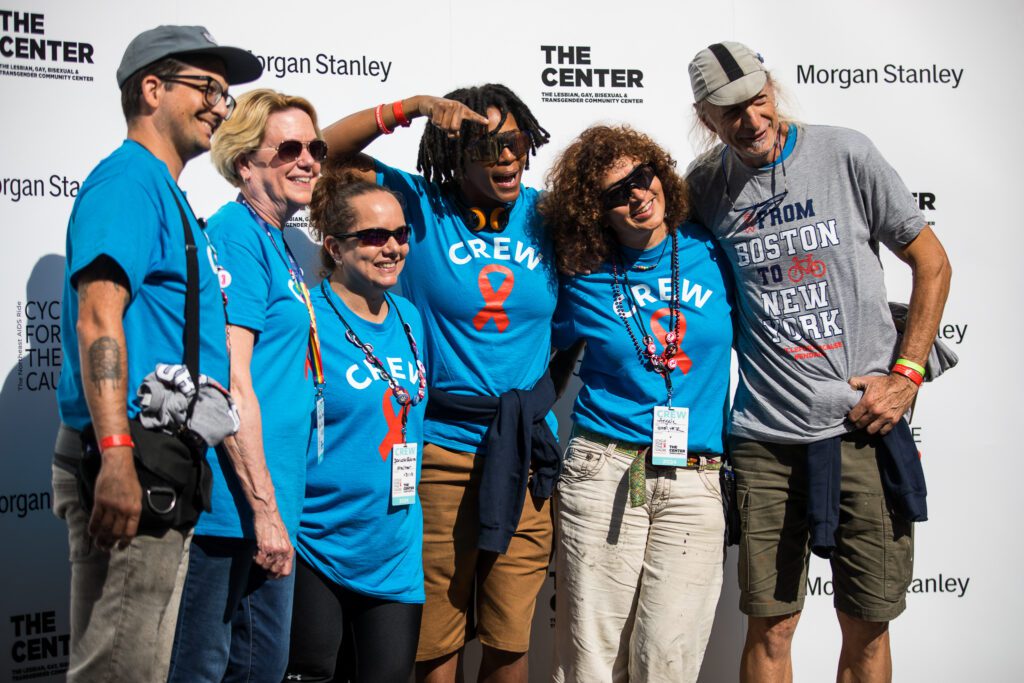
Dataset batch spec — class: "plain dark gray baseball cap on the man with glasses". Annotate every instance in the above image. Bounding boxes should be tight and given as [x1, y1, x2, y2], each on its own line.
[118, 26, 263, 88]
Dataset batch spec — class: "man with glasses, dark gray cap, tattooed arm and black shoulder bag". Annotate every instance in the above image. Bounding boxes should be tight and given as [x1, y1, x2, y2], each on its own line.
[53, 26, 262, 682]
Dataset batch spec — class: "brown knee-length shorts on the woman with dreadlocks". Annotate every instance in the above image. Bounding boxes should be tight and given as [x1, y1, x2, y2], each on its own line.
[416, 443, 552, 661]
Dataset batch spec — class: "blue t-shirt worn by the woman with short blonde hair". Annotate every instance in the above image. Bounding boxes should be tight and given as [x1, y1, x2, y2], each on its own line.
[196, 202, 315, 541]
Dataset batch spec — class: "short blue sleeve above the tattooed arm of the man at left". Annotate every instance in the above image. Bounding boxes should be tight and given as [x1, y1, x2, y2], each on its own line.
[69, 175, 159, 298]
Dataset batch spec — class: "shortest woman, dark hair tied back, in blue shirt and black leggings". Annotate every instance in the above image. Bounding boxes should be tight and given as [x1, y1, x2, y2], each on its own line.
[286, 174, 426, 683]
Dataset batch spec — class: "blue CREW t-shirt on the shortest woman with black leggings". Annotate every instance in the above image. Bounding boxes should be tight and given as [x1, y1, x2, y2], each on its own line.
[297, 286, 426, 603]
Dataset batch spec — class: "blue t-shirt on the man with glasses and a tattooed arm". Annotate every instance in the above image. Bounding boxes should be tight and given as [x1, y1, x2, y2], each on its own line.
[57, 140, 229, 432]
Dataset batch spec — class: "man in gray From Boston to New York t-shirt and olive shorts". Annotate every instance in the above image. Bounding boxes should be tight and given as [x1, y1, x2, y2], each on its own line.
[688, 42, 950, 681]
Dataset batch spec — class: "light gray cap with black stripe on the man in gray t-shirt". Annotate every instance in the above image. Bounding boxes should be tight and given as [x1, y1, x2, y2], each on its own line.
[690, 42, 768, 106]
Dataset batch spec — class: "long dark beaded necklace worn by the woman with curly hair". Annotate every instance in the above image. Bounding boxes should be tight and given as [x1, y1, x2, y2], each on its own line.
[611, 230, 680, 405]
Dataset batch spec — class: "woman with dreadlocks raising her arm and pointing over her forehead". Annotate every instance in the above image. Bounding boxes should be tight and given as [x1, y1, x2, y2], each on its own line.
[325, 84, 560, 683]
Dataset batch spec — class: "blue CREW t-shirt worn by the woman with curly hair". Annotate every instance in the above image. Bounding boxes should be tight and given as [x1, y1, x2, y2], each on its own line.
[553, 223, 732, 453]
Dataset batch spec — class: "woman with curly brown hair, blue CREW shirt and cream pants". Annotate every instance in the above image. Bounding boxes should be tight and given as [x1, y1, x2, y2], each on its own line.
[541, 126, 732, 683]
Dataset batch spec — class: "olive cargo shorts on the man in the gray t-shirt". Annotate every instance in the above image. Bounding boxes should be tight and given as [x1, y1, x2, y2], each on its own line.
[729, 436, 913, 622]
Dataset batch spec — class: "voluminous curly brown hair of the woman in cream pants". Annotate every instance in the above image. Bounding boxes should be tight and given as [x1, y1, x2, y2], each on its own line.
[540, 126, 690, 272]
